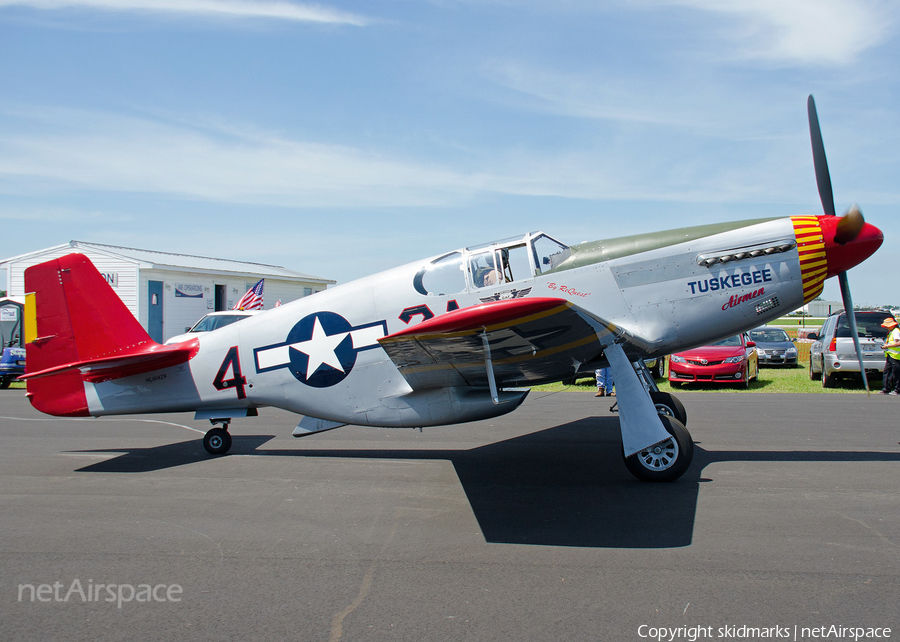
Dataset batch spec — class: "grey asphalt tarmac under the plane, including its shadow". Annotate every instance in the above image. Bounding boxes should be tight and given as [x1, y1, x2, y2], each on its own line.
[0, 390, 900, 642]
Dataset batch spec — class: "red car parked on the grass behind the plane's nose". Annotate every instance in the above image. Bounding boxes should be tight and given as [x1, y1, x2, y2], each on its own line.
[669, 333, 759, 388]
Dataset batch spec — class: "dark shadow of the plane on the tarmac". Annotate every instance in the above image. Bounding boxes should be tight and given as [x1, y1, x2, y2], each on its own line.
[72, 417, 900, 548]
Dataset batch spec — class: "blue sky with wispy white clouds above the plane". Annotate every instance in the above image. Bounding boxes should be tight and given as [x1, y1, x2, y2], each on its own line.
[0, 0, 900, 305]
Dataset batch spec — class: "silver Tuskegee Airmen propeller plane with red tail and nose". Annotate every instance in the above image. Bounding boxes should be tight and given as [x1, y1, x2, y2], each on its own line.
[19, 97, 883, 481]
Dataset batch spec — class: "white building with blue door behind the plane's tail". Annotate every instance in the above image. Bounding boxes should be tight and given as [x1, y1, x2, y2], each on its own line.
[0, 241, 335, 343]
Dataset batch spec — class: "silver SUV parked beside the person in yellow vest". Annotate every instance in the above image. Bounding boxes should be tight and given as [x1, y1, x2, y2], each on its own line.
[809, 310, 894, 388]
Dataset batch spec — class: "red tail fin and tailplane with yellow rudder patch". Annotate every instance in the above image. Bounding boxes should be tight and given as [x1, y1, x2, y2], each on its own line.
[23, 254, 197, 417]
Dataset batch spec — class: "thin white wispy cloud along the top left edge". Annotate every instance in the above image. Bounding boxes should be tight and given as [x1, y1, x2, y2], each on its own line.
[0, 0, 368, 26]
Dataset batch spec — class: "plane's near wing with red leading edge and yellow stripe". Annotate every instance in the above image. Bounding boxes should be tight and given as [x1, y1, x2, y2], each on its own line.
[379, 298, 624, 390]
